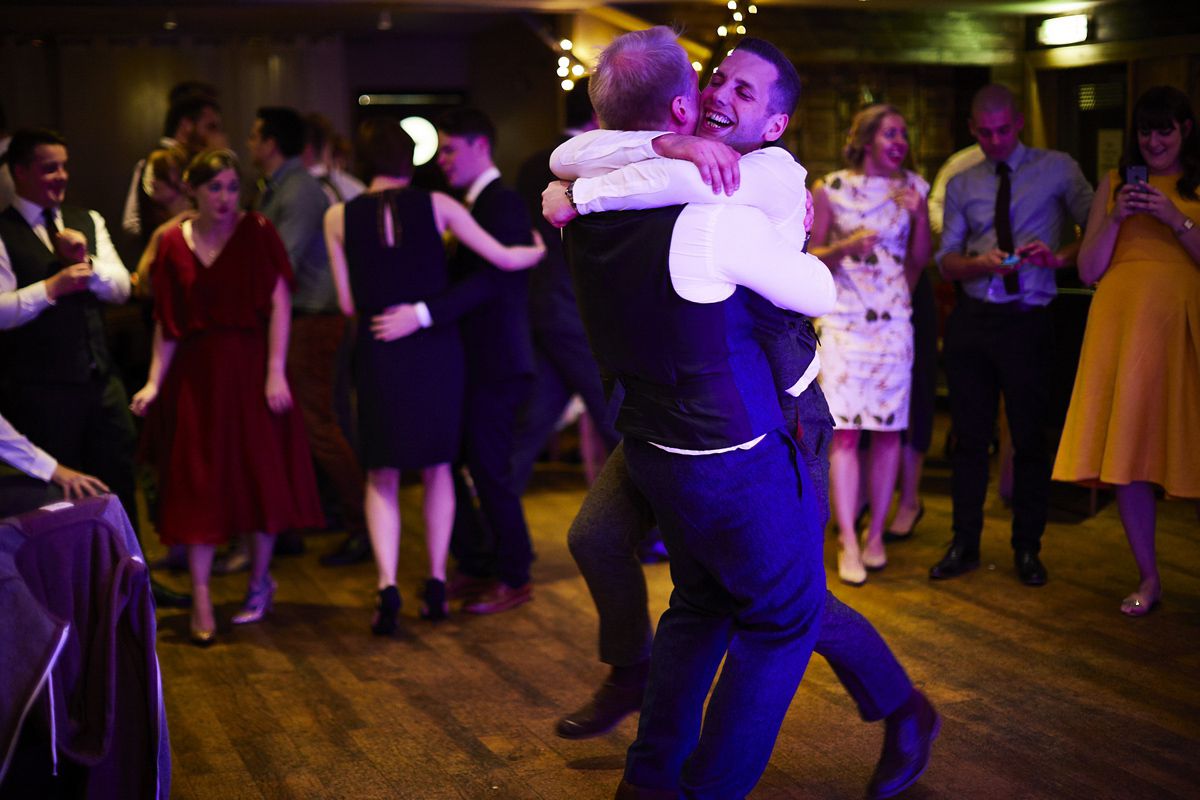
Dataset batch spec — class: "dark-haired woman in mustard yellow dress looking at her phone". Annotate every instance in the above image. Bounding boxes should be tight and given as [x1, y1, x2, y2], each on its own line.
[1054, 86, 1200, 616]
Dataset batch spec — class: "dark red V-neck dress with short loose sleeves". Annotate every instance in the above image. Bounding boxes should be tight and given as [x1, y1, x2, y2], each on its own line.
[138, 213, 324, 545]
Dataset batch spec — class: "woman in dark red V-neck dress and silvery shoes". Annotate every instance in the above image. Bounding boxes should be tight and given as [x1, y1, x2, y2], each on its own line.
[132, 150, 323, 645]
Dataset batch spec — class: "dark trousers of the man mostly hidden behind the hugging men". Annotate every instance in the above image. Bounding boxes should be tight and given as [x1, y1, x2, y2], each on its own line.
[512, 330, 620, 492]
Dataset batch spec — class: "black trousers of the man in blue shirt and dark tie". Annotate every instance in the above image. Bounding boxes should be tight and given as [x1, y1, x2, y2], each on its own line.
[942, 296, 1054, 553]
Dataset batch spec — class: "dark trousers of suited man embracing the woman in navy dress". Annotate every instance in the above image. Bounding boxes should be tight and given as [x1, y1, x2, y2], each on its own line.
[450, 375, 533, 589]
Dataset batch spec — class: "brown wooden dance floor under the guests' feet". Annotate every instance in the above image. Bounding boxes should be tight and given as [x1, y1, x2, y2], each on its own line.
[158, 438, 1200, 800]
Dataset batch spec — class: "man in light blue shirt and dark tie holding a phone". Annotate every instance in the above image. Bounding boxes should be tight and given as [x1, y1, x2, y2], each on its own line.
[929, 84, 1092, 587]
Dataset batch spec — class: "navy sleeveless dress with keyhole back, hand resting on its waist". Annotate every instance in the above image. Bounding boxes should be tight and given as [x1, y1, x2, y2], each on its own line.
[346, 188, 466, 469]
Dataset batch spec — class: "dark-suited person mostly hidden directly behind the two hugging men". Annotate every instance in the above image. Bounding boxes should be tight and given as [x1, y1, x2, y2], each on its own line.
[512, 78, 620, 491]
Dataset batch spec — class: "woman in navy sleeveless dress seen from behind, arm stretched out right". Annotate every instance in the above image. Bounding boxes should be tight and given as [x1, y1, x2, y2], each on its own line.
[325, 118, 545, 636]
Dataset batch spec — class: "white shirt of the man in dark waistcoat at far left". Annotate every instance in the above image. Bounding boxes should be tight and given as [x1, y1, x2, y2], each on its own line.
[0, 196, 131, 330]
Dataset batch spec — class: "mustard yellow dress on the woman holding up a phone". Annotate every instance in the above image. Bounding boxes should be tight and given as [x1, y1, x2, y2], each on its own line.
[1054, 170, 1200, 498]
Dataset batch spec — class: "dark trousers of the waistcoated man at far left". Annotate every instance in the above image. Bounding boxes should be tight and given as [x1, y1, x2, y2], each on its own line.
[5, 373, 138, 531]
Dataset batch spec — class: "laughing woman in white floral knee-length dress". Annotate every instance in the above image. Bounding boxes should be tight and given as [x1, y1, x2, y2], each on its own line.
[811, 104, 932, 585]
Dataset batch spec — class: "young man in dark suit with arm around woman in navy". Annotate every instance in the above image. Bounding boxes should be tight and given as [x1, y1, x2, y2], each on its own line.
[376, 108, 533, 614]
